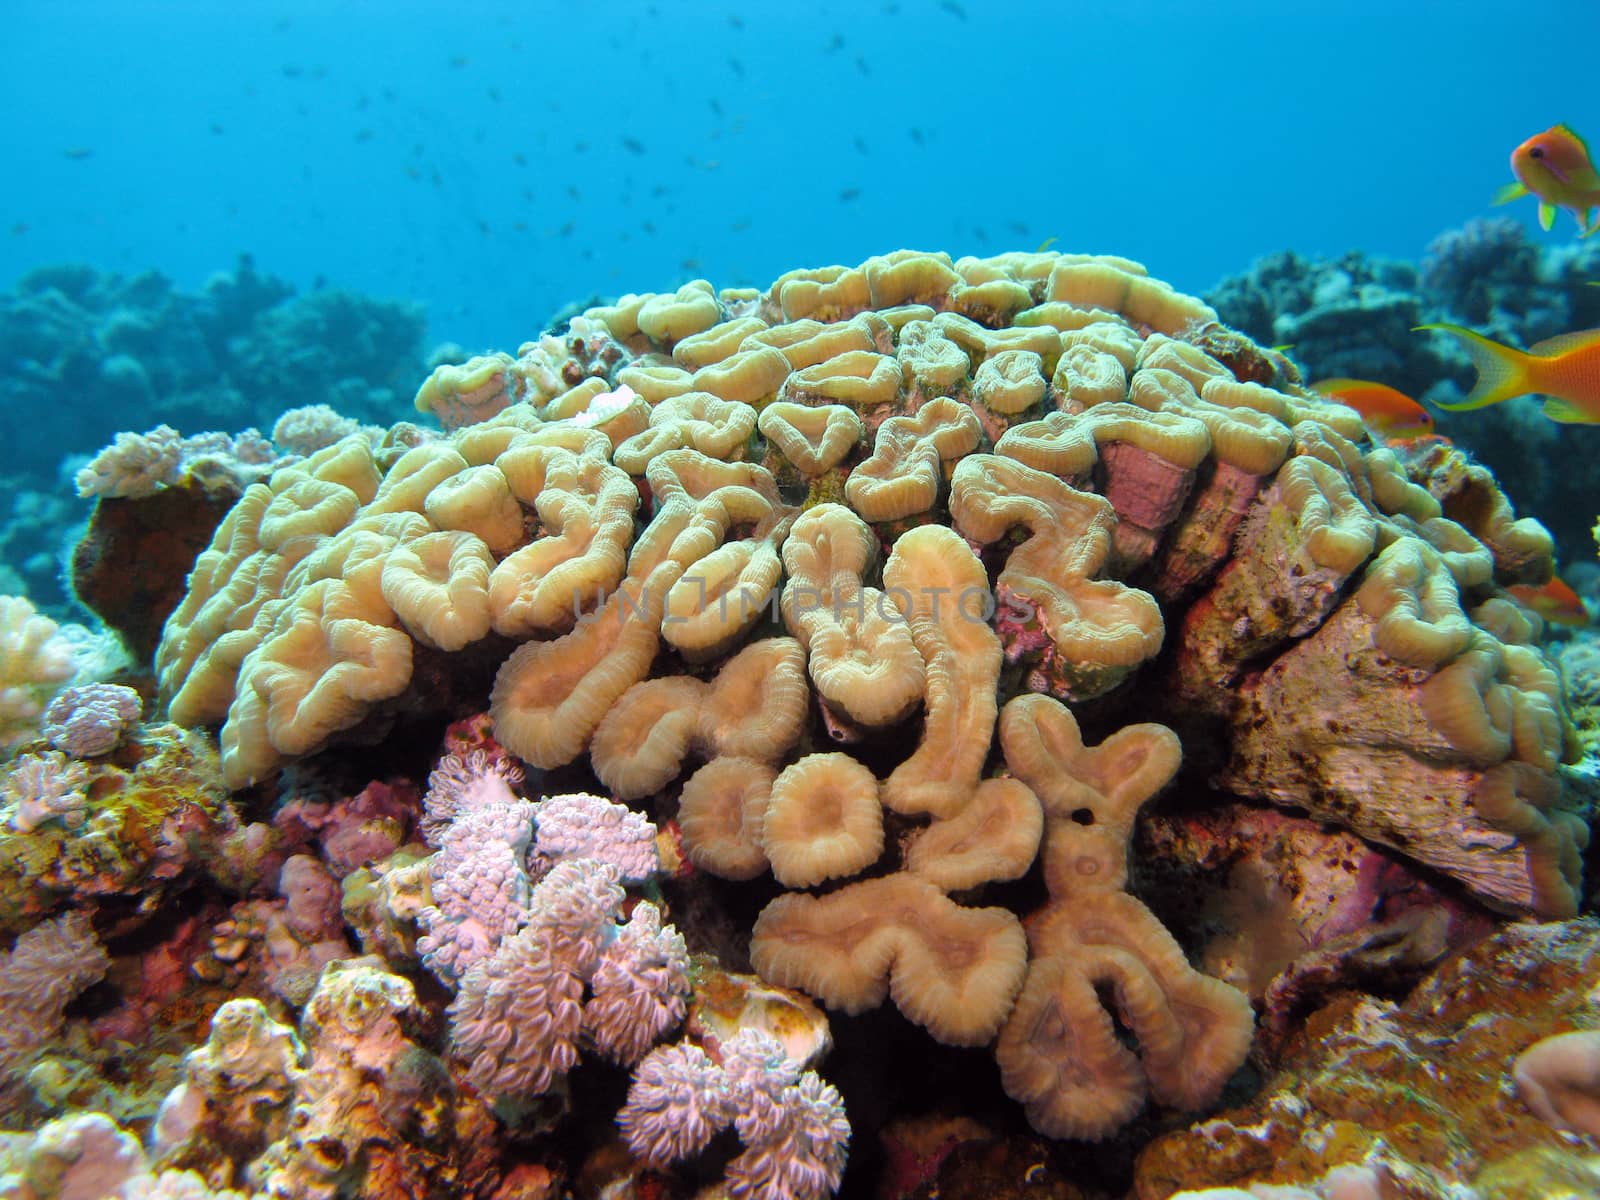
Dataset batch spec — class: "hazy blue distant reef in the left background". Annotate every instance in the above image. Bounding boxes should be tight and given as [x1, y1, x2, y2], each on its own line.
[0, 256, 422, 489]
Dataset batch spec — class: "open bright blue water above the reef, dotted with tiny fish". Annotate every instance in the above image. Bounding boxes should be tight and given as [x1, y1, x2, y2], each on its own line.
[0, 0, 1600, 349]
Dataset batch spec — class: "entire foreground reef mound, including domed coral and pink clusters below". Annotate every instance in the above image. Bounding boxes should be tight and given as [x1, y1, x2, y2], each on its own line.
[0, 246, 1595, 1200]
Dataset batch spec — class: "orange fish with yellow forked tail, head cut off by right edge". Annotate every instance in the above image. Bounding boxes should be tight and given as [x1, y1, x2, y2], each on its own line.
[1416, 325, 1600, 426]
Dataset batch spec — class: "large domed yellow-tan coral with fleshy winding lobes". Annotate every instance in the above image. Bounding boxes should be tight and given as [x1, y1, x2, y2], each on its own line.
[157, 251, 1586, 1134]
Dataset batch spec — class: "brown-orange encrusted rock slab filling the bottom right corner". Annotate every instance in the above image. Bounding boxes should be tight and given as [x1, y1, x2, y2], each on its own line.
[1134, 918, 1600, 1200]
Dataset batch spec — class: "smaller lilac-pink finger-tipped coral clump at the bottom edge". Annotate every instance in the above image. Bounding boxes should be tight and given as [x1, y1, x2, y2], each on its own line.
[616, 1029, 850, 1200]
